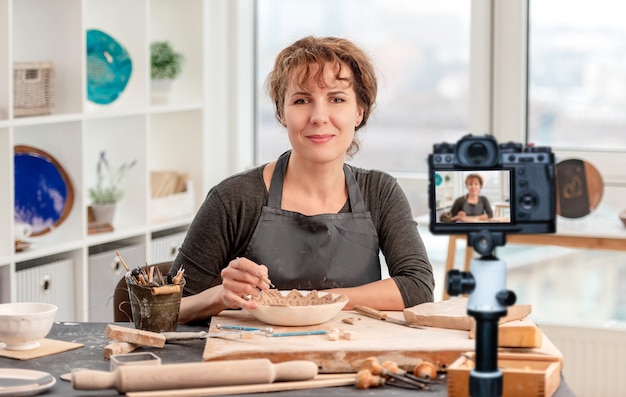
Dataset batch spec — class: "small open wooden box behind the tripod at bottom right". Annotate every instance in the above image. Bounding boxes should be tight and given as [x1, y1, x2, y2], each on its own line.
[448, 353, 561, 397]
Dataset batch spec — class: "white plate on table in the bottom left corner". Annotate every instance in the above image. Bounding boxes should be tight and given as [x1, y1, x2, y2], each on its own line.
[0, 368, 56, 396]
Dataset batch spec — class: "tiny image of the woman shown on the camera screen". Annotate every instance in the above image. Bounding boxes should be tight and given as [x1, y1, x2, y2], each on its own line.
[450, 174, 493, 222]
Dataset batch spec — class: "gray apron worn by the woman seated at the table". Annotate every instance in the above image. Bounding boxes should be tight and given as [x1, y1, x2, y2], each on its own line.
[246, 151, 381, 290]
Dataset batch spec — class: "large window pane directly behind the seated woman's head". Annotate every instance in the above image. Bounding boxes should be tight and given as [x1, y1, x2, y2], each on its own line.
[256, 0, 471, 174]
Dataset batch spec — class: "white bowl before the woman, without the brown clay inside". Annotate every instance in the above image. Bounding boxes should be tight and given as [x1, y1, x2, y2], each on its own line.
[249, 291, 348, 327]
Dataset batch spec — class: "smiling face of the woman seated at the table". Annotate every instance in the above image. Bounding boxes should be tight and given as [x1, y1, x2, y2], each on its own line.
[283, 63, 363, 163]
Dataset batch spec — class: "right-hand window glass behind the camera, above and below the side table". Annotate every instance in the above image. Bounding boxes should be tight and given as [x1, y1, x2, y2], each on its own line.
[520, 0, 626, 324]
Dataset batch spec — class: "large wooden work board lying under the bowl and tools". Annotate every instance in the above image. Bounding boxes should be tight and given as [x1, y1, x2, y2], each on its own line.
[202, 310, 562, 373]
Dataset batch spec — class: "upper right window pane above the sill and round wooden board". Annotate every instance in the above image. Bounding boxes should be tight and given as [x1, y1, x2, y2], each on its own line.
[528, 0, 626, 151]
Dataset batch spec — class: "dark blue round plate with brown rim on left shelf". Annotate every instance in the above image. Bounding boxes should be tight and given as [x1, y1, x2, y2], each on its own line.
[14, 146, 74, 236]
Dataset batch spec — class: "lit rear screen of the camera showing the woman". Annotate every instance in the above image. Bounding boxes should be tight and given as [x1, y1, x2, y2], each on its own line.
[432, 169, 511, 224]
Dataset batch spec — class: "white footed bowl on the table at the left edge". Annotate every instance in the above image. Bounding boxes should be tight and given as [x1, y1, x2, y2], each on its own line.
[0, 303, 57, 350]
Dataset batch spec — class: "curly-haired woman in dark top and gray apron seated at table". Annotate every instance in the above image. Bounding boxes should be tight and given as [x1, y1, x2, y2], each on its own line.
[172, 37, 434, 323]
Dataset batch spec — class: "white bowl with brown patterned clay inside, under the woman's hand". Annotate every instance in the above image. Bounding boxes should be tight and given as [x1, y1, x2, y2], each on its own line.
[249, 289, 348, 327]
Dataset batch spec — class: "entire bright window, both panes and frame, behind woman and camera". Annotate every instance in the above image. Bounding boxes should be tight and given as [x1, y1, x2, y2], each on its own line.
[250, 0, 626, 324]
